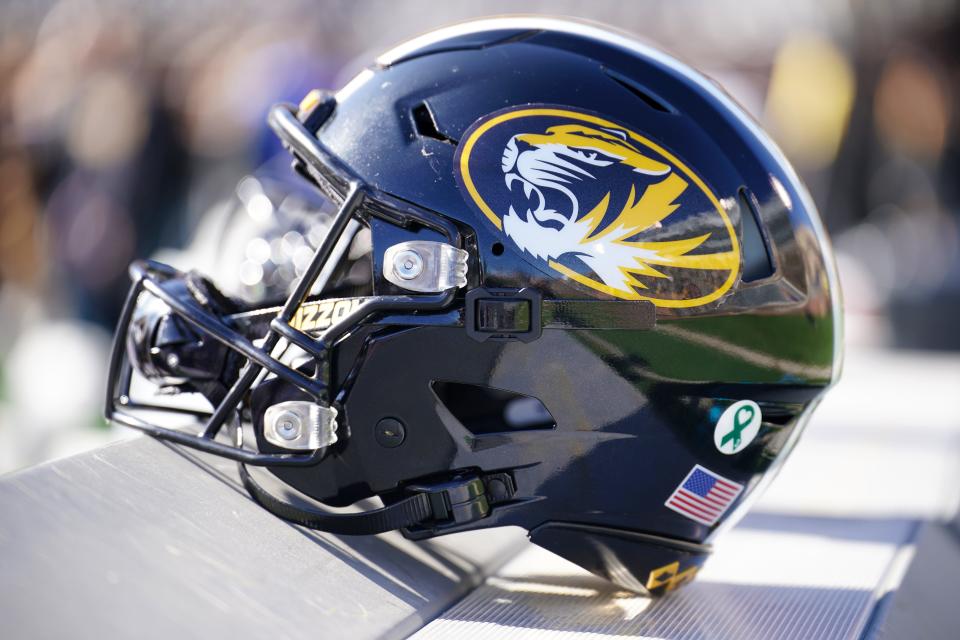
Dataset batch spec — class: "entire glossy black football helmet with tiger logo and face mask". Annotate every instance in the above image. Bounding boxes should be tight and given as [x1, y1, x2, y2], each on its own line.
[107, 18, 841, 593]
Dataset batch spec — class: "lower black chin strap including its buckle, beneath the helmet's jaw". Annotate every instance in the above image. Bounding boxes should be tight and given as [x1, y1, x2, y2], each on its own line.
[237, 462, 516, 536]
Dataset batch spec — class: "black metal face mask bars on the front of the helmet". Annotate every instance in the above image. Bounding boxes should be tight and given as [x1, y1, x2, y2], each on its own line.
[105, 94, 464, 467]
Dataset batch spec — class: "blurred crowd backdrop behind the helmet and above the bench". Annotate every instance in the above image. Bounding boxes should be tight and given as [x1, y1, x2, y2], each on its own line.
[0, 0, 960, 472]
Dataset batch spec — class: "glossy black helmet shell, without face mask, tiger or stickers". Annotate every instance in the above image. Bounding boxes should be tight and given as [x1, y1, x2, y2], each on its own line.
[275, 18, 841, 588]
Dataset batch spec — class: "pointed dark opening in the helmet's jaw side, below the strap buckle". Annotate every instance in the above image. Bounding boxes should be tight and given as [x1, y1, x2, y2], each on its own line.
[432, 380, 557, 435]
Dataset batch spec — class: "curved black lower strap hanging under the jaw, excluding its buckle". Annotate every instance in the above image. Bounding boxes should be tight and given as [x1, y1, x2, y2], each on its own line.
[237, 462, 433, 536]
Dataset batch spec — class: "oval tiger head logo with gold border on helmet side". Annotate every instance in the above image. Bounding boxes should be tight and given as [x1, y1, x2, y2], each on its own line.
[456, 107, 740, 307]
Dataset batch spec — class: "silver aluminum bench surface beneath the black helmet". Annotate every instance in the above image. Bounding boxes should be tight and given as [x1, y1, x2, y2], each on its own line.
[0, 351, 960, 640]
